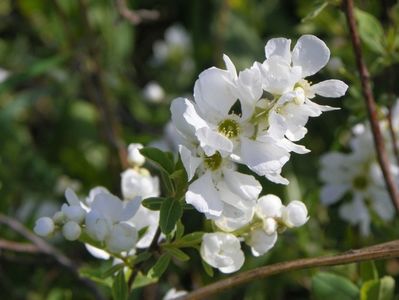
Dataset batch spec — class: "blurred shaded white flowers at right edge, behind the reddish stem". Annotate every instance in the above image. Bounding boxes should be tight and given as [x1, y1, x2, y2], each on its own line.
[319, 113, 399, 236]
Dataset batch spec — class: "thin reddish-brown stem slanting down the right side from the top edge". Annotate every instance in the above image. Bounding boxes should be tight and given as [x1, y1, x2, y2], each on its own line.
[344, 0, 399, 212]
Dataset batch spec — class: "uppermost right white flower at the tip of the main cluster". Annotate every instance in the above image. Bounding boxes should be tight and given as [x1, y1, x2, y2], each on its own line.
[257, 35, 348, 141]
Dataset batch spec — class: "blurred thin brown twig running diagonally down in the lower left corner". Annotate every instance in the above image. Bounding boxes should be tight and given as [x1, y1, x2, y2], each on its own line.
[0, 213, 105, 299]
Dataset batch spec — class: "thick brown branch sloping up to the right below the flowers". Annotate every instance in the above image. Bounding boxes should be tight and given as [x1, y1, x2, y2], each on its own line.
[185, 240, 399, 299]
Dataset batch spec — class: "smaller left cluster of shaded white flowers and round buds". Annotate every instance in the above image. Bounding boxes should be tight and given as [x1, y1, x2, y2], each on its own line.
[34, 144, 159, 259]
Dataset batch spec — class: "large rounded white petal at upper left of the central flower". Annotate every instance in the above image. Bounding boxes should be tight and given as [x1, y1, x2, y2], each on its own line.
[194, 67, 237, 122]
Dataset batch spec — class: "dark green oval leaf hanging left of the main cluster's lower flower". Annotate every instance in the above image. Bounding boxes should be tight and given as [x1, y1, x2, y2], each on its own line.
[159, 198, 183, 234]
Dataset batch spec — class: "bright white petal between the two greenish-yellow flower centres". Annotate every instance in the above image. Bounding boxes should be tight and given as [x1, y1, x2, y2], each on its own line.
[196, 127, 233, 156]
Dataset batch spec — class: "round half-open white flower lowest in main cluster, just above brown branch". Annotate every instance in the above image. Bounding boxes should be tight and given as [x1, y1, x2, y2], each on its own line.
[200, 232, 245, 273]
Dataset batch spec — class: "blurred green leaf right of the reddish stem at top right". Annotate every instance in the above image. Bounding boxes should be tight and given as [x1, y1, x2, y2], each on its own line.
[355, 8, 385, 54]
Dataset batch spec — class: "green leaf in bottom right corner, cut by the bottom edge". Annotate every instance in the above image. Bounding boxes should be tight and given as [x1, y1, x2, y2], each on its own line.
[360, 276, 395, 300]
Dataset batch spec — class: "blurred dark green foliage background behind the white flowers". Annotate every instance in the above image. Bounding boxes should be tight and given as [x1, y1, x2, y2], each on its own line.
[0, 0, 399, 299]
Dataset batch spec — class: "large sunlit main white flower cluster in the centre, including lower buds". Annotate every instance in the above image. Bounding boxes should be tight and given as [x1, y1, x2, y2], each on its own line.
[171, 35, 347, 272]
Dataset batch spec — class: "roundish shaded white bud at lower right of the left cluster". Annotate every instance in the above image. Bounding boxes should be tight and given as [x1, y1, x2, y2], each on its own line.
[106, 223, 138, 253]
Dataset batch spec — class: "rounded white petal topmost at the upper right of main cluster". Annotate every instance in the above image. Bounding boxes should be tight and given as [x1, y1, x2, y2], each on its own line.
[292, 35, 330, 77]
